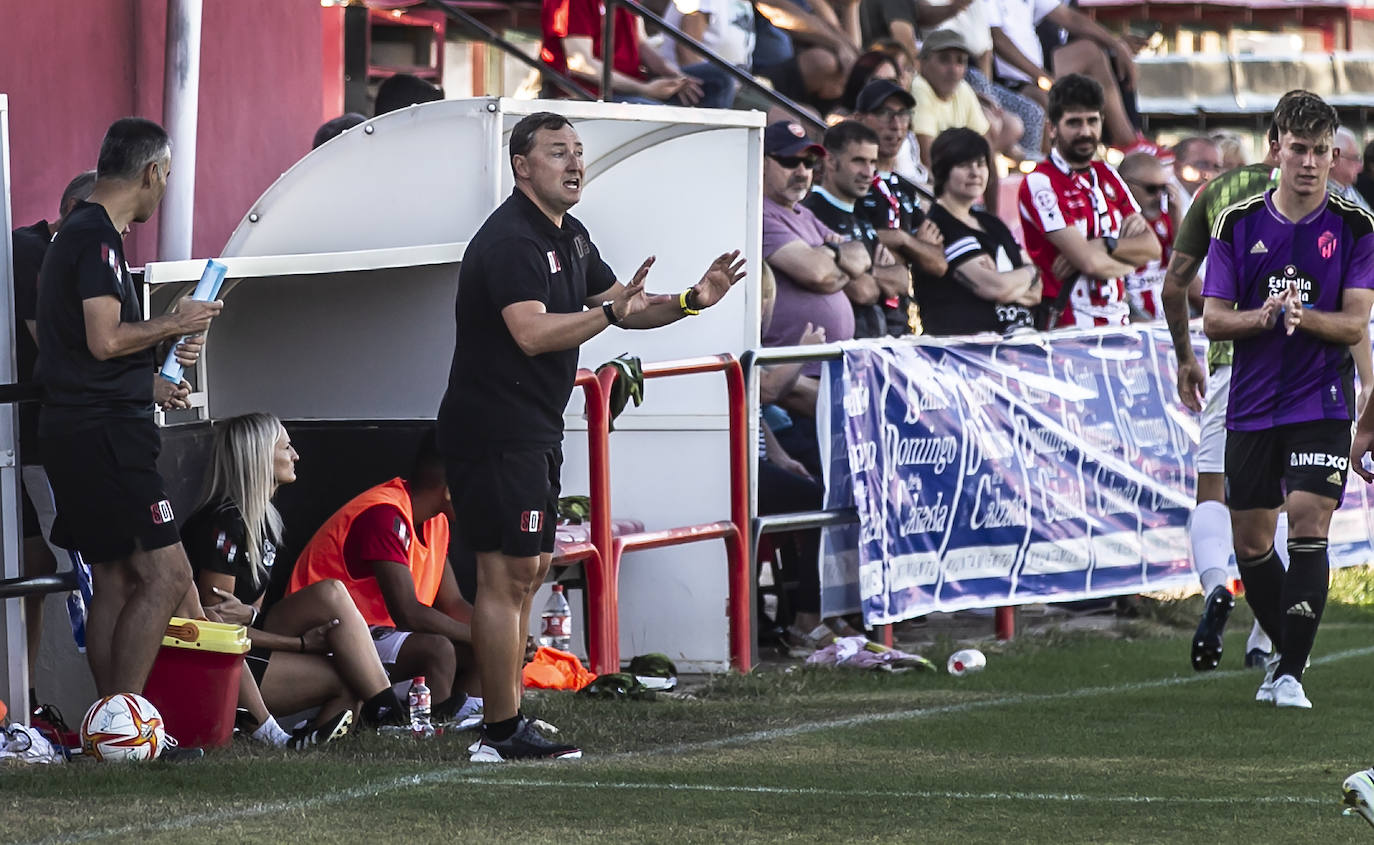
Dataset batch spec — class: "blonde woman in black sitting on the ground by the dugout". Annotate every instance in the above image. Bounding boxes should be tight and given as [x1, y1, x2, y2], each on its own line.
[181, 414, 403, 747]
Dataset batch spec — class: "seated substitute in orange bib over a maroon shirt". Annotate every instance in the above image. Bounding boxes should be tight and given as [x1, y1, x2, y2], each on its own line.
[286, 433, 475, 720]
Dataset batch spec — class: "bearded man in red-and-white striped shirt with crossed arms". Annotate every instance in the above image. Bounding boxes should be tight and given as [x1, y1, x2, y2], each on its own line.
[1018, 74, 1160, 328]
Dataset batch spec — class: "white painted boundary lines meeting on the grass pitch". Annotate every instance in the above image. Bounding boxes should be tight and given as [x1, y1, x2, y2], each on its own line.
[36, 646, 1374, 844]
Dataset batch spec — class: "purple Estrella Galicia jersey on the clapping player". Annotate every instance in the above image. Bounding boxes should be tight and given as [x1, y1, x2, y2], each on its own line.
[1202, 191, 1374, 431]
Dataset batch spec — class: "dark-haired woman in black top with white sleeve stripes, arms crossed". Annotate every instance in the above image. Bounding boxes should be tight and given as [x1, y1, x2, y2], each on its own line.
[916, 129, 1040, 335]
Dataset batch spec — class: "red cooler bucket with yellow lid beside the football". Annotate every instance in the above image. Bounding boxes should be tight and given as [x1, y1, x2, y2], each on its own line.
[143, 617, 251, 749]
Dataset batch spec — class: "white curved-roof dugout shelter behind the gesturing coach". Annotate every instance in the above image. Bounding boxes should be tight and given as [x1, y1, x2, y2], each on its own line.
[0, 99, 764, 712]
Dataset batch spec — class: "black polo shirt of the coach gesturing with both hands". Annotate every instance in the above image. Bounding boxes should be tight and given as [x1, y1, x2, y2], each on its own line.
[438, 188, 616, 458]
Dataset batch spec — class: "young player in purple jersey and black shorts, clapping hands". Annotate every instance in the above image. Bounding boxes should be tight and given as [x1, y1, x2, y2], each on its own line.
[1202, 93, 1374, 708]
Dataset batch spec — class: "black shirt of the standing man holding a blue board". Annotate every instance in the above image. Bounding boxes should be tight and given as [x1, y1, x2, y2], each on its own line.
[37, 202, 157, 437]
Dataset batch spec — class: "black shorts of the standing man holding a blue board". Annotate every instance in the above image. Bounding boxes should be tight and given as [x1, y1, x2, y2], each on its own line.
[43, 419, 180, 563]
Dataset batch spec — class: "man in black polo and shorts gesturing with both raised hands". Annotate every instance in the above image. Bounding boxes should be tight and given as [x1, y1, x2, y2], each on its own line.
[438, 113, 743, 763]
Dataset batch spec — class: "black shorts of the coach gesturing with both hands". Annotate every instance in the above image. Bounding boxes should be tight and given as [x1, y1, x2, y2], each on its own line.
[445, 447, 563, 558]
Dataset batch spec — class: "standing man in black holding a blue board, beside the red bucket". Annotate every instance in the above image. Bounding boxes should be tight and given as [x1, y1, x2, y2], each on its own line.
[37, 117, 221, 695]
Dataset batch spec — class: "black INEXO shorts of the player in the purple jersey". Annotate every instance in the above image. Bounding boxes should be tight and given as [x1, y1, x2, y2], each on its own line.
[1226, 419, 1351, 511]
